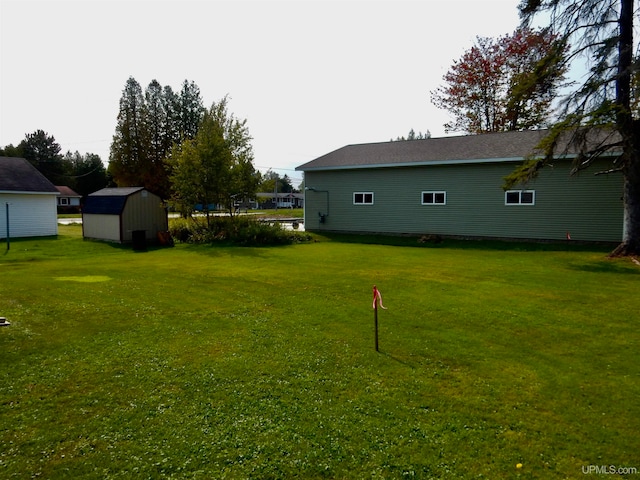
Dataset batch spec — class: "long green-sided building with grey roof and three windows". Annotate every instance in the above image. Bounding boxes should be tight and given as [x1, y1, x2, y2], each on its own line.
[297, 131, 623, 243]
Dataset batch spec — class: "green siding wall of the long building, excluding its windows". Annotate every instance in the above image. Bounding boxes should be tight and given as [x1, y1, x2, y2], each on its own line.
[305, 161, 623, 242]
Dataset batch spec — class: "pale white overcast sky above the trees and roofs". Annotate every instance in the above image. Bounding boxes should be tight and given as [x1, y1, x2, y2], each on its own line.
[0, 0, 519, 186]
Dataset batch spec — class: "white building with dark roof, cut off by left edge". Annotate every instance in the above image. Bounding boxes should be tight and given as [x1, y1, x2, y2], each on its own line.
[0, 157, 60, 238]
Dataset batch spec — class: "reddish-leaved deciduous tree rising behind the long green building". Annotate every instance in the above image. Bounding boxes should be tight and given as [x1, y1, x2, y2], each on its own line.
[431, 28, 565, 134]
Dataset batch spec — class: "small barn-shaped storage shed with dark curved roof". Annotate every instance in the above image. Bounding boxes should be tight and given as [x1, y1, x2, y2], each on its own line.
[82, 187, 169, 247]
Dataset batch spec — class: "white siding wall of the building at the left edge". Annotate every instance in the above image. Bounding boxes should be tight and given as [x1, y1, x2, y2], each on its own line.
[0, 193, 58, 238]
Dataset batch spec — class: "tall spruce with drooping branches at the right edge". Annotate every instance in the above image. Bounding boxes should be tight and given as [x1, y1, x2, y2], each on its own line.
[505, 0, 640, 255]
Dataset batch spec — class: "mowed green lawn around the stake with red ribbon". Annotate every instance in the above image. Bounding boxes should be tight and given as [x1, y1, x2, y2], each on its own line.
[0, 226, 640, 479]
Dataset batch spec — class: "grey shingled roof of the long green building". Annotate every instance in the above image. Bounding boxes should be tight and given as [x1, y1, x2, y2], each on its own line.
[296, 130, 620, 171]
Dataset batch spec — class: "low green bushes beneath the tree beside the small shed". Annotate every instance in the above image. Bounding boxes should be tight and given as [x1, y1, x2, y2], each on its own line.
[169, 217, 311, 247]
